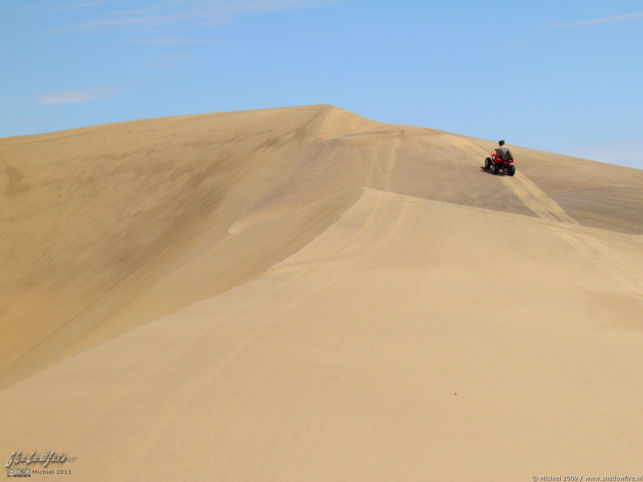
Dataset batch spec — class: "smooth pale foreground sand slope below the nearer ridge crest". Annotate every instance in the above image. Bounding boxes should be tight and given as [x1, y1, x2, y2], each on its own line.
[0, 189, 643, 481]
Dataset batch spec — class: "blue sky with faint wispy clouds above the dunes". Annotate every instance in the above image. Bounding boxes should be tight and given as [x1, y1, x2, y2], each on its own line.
[0, 0, 643, 169]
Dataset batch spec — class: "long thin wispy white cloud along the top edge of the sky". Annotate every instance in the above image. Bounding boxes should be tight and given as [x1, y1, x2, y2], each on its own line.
[58, 0, 339, 33]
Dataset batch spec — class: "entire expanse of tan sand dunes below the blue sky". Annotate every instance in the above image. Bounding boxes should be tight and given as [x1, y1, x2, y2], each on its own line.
[0, 106, 643, 481]
